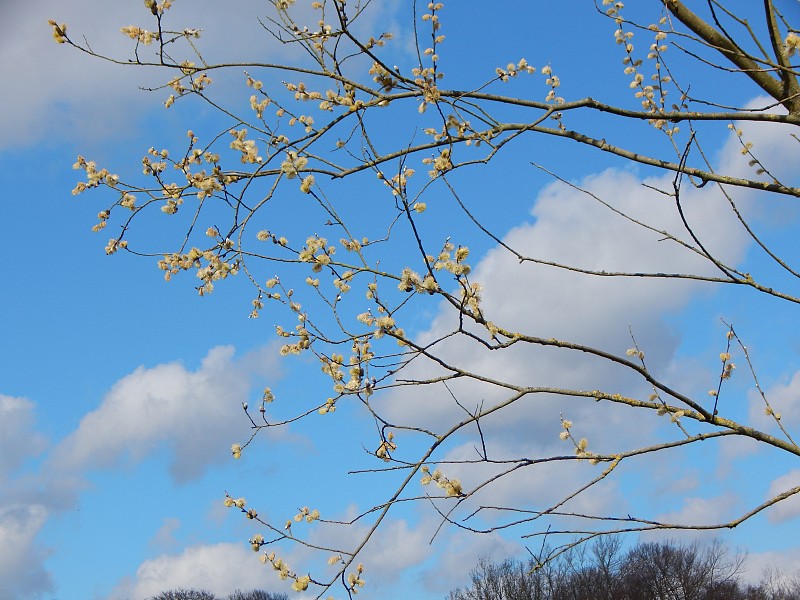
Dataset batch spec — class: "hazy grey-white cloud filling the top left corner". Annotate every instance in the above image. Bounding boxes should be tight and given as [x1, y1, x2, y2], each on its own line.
[0, 0, 406, 148]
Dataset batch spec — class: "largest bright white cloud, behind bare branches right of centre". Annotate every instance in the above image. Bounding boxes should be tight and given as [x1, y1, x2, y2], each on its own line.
[388, 157, 764, 439]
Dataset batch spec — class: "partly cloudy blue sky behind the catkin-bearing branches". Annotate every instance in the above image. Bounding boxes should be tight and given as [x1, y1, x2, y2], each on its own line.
[0, 0, 800, 600]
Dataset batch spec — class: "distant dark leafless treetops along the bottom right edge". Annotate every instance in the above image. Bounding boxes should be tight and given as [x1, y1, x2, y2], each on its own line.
[447, 538, 800, 600]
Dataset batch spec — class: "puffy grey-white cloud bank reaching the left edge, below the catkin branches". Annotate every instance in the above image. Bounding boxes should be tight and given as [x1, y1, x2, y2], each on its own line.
[0, 346, 280, 600]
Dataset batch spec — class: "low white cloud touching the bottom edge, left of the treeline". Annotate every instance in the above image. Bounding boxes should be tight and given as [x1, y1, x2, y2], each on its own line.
[110, 543, 280, 598]
